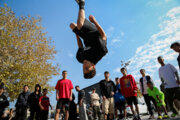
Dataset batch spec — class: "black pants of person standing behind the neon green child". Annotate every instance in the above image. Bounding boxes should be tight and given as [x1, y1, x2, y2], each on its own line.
[143, 94, 157, 115]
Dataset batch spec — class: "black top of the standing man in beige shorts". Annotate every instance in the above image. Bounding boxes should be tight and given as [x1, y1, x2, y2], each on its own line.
[100, 80, 116, 98]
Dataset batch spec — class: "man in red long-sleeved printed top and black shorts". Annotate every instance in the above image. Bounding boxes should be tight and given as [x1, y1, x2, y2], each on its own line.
[120, 68, 141, 120]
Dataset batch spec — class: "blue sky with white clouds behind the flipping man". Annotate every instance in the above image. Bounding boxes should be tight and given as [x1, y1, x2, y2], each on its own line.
[0, 0, 180, 107]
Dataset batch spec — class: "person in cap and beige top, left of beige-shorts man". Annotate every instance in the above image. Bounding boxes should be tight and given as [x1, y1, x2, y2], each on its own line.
[91, 88, 101, 120]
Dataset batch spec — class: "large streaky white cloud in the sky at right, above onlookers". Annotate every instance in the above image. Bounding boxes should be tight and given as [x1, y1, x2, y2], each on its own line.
[114, 7, 180, 85]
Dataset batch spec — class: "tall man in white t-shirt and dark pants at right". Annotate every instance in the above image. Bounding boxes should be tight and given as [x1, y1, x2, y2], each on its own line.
[157, 56, 180, 117]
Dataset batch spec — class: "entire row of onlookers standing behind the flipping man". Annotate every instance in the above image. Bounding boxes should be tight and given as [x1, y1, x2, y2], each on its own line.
[0, 42, 180, 120]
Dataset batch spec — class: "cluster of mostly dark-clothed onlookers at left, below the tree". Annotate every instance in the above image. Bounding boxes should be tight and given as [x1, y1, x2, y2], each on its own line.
[0, 84, 52, 120]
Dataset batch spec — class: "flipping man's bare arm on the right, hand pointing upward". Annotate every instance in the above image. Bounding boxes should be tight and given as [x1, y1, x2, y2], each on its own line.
[89, 15, 106, 40]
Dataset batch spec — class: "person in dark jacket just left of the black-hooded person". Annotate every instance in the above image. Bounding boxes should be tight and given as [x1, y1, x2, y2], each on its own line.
[15, 85, 30, 120]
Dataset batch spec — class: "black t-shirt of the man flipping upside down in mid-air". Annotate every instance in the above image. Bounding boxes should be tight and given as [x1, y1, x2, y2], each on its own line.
[76, 36, 108, 64]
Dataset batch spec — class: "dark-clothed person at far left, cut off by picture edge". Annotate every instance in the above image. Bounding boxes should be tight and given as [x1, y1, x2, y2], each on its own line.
[0, 84, 9, 120]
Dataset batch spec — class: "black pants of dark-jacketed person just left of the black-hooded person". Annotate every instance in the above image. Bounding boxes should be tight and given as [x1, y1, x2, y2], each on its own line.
[15, 108, 27, 120]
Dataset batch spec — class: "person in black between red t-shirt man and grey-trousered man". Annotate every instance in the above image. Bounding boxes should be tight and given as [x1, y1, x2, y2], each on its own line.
[69, 93, 77, 120]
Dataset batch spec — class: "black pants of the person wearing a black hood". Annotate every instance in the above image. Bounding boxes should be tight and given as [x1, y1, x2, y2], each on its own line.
[29, 108, 40, 120]
